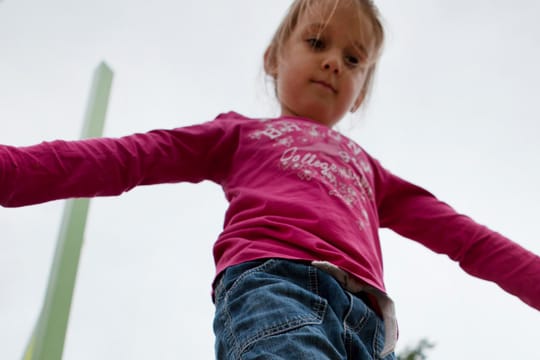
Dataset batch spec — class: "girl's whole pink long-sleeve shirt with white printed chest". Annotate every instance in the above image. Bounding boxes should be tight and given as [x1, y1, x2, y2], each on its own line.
[0, 112, 540, 310]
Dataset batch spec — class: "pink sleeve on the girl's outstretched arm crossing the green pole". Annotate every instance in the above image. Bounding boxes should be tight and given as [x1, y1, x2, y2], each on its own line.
[0, 118, 237, 207]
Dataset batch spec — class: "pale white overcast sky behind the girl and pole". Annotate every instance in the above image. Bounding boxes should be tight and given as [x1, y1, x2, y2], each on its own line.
[0, 0, 540, 360]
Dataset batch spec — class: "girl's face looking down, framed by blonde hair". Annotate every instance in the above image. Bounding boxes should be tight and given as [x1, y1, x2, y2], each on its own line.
[267, 1, 369, 127]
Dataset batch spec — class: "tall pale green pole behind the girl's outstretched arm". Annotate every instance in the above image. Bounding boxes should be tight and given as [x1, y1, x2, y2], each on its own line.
[23, 62, 113, 360]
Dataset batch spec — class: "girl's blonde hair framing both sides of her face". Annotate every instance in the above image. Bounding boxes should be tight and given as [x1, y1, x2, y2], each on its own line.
[264, 0, 384, 109]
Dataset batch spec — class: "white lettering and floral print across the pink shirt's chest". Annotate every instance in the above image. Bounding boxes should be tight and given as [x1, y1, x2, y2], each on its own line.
[249, 120, 373, 214]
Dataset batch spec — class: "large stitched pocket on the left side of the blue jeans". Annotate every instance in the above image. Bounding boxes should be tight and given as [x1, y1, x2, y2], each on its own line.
[214, 260, 328, 357]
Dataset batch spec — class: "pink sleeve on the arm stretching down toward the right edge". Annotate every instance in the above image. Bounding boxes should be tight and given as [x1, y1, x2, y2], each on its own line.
[374, 156, 540, 310]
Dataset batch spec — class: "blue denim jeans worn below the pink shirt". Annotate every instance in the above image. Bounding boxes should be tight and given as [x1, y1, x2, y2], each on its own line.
[214, 259, 395, 360]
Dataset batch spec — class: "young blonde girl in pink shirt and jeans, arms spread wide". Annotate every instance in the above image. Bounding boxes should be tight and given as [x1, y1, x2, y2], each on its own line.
[0, 0, 540, 359]
